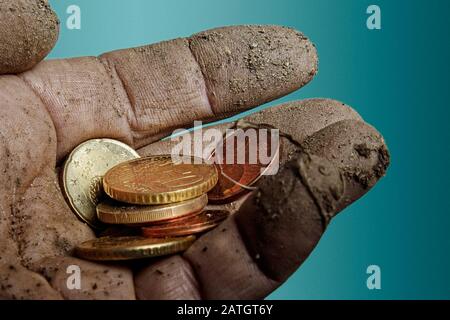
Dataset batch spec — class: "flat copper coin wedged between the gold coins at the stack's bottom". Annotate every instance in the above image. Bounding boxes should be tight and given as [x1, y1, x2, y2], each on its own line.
[142, 210, 229, 237]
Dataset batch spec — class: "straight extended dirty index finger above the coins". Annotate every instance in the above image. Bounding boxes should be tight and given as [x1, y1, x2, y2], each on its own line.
[21, 26, 317, 159]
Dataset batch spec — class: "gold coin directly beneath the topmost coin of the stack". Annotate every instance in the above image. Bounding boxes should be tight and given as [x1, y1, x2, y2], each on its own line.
[97, 194, 208, 225]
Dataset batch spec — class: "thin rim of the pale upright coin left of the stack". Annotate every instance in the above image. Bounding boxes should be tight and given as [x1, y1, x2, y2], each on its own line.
[61, 138, 140, 229]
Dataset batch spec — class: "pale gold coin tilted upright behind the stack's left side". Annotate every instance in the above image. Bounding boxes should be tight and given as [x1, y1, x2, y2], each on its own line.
[61, 139, 139, 228]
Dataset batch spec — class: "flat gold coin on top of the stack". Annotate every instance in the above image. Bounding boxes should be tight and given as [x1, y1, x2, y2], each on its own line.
[103, 155, 218, 205]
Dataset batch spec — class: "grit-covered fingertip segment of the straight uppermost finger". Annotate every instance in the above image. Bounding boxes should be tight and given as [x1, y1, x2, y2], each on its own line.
[189, 25, 318, 113]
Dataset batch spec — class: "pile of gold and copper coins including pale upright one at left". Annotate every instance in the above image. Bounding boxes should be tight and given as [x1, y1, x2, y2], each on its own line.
[62, 139, 228, 260]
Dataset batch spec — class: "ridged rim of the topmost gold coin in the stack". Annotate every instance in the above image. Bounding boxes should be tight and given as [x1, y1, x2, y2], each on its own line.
[102, 155, 219, 205]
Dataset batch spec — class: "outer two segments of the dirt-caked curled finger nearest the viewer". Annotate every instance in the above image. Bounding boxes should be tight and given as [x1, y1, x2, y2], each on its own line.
[236, 120, 390, 281]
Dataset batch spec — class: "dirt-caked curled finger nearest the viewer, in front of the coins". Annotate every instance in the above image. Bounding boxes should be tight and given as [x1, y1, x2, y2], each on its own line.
[184, 120, 389, 299]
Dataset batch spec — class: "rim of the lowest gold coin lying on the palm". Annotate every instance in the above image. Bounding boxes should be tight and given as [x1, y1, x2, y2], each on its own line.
[75, 235, 196, 261]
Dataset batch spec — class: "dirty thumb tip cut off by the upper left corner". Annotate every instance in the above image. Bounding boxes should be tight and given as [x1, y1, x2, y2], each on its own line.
[0, 0, 59, 74]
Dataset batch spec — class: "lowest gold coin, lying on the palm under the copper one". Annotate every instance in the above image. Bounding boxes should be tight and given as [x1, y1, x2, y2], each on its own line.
[75, 236, 195, 261]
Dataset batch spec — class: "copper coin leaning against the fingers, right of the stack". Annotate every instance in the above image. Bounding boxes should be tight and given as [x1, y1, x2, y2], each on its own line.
[208, 130, 279, 203]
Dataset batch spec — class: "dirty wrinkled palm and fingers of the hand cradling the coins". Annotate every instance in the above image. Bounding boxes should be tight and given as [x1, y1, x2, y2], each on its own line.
[0, 26, 389, 299]
